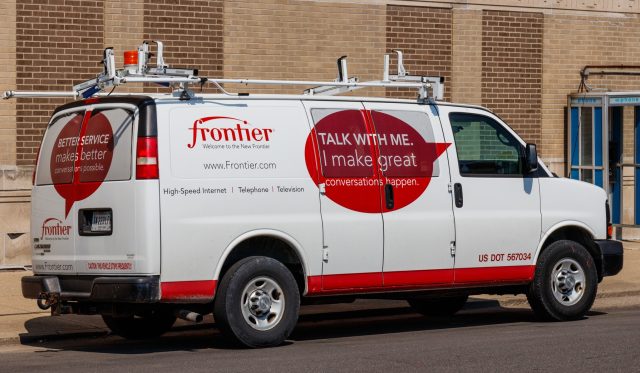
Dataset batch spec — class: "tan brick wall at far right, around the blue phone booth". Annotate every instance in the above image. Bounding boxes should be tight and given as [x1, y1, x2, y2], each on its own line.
[541, 14, 640, 175]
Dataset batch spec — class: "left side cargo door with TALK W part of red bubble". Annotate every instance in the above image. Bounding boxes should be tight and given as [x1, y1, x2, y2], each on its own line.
[304, 101, 383, 290]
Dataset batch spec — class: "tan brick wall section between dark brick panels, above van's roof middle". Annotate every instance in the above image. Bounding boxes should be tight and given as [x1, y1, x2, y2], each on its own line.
[224, 0, 385, 95]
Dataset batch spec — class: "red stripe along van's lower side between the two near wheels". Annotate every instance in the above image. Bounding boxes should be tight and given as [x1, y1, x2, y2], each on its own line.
[307, 266, 535, 295]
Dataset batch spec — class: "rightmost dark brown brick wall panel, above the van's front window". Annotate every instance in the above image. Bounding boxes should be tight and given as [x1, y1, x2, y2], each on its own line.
[482, 10, 543, 143]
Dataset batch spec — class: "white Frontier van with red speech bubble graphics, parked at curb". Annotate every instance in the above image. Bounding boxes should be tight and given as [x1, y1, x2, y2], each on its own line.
[12, 45, 623, 347]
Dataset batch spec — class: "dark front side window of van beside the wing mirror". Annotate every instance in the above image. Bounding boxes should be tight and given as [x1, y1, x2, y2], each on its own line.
[449, 113, 523, 177]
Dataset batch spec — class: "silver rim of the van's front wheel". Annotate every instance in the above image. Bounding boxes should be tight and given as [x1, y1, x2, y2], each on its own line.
[551, 258, 587, 306]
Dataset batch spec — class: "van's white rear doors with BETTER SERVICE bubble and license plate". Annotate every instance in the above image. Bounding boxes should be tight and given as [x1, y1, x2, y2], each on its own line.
[32, 100, 159, 274]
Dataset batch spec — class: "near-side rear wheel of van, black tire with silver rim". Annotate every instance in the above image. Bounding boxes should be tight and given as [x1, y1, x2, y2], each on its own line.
[213, 256, 300, 348]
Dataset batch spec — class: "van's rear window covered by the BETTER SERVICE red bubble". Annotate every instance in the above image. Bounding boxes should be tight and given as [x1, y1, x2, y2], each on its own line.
[36, 108, 133, 185]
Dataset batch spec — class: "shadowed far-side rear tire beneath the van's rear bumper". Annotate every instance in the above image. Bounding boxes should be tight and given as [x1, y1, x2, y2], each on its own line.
[102, 309, 176, 339]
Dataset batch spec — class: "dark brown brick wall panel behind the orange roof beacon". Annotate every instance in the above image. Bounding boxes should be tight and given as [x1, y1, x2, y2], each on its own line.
[143, 0, 224, 92]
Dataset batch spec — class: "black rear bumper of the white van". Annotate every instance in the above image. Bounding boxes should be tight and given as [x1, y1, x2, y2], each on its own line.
[22, 275, 160, 303]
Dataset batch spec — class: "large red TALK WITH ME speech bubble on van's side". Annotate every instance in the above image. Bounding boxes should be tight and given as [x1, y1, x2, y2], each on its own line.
[305, 110, 450, 213]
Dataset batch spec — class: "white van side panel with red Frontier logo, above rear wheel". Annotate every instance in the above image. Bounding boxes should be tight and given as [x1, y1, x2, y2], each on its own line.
[157, 100, 322, 288]
